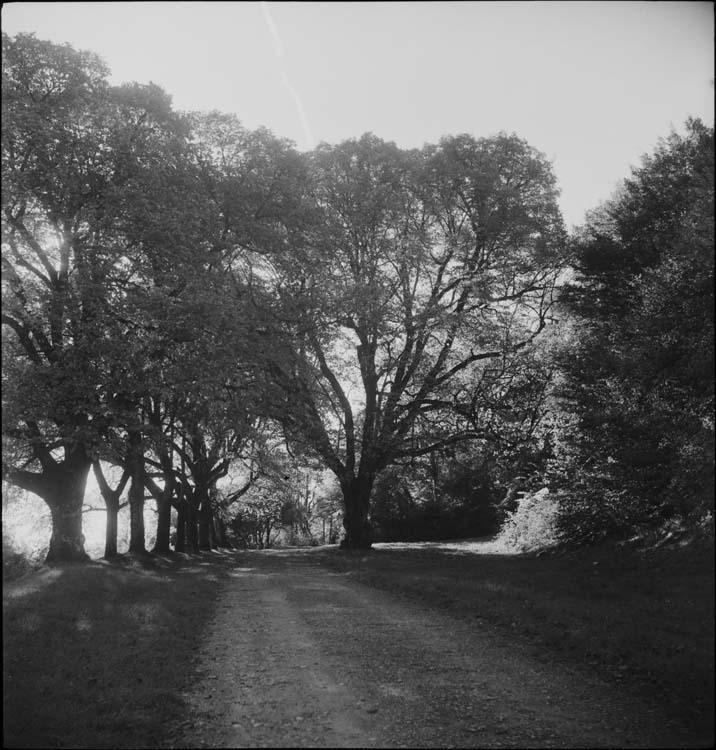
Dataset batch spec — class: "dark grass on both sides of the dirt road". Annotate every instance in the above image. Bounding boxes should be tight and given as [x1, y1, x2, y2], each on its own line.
[3, 541, 714, 748]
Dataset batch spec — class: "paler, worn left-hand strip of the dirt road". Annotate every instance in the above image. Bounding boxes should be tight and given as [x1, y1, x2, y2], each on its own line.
[174, 569, 380, 747]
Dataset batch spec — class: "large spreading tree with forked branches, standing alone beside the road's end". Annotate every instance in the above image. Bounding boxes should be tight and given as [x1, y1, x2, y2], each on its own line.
[256, 135, 564, 548]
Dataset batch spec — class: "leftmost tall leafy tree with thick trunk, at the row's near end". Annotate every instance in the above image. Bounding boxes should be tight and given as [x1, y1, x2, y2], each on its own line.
[2, 34, 114, 561]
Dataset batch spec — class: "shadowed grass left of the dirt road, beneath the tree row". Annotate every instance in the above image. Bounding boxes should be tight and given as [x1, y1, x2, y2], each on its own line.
[3, 553, 246, 748]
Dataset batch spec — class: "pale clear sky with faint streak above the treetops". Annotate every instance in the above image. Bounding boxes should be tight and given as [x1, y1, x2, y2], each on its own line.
[2, 0, 714, 227]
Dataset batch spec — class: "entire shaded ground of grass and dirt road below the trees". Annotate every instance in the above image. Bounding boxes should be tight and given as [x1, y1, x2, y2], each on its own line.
[3, 541, 714, 748]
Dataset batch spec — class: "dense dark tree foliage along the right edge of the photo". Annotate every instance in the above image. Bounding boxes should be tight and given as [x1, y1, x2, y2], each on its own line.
[558, 121, 714, 538]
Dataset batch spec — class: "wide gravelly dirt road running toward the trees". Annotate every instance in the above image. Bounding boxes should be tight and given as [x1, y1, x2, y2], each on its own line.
[170, 550, 683, 748]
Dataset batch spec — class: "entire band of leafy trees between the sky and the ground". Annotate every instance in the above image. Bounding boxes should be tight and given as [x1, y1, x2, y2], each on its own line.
[2, 34, 714, 561]
